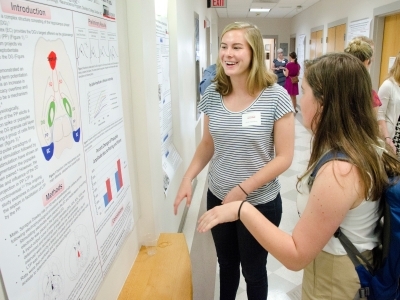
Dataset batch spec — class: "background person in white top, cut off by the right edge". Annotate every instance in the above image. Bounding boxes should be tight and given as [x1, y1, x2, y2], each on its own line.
[378, 52, 400, 152]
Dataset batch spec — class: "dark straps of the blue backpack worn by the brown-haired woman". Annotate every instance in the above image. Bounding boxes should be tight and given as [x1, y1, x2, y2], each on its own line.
[308, 150, 373, 274]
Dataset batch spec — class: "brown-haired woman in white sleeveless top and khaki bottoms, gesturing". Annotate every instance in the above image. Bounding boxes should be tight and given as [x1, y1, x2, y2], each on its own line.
[198, 53, 400, 300]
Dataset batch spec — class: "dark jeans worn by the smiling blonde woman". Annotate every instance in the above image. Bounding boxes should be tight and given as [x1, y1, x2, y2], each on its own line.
[207, 190, 282, 300]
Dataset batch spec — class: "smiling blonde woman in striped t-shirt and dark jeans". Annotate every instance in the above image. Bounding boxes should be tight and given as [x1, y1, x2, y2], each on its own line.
[174, 22, 294, 300]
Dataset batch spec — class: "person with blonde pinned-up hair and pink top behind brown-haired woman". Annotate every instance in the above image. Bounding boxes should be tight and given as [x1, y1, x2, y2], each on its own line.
[344, 37, 382, 115]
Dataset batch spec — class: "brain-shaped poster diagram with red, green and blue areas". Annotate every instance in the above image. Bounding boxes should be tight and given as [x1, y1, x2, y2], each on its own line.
[33, 38, 81, 161]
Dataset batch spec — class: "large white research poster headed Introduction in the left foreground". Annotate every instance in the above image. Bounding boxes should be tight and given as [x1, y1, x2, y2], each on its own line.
[0, 0, 134, 300]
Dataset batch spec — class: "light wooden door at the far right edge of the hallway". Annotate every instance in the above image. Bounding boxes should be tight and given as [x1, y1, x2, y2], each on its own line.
[379, 14, 400, 86]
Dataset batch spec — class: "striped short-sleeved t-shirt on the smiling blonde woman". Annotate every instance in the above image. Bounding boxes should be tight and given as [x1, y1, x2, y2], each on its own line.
[199, 84, 293, 205]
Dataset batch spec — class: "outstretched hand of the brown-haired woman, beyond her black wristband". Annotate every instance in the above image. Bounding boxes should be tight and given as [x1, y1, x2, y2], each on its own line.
[197, 201, 242, 232]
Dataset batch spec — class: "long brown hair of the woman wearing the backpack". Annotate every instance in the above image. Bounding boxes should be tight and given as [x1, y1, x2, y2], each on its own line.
[299, 53, 400, 200]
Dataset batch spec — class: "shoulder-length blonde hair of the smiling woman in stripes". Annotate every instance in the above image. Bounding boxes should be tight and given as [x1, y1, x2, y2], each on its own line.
[213, 22, 276, 96]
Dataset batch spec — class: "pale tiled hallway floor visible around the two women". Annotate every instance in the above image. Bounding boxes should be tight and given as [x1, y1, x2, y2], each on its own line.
[184, 112, 310, 300]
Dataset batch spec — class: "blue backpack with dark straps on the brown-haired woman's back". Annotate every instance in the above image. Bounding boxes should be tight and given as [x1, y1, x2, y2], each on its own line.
[308, 151, 400, 300]
